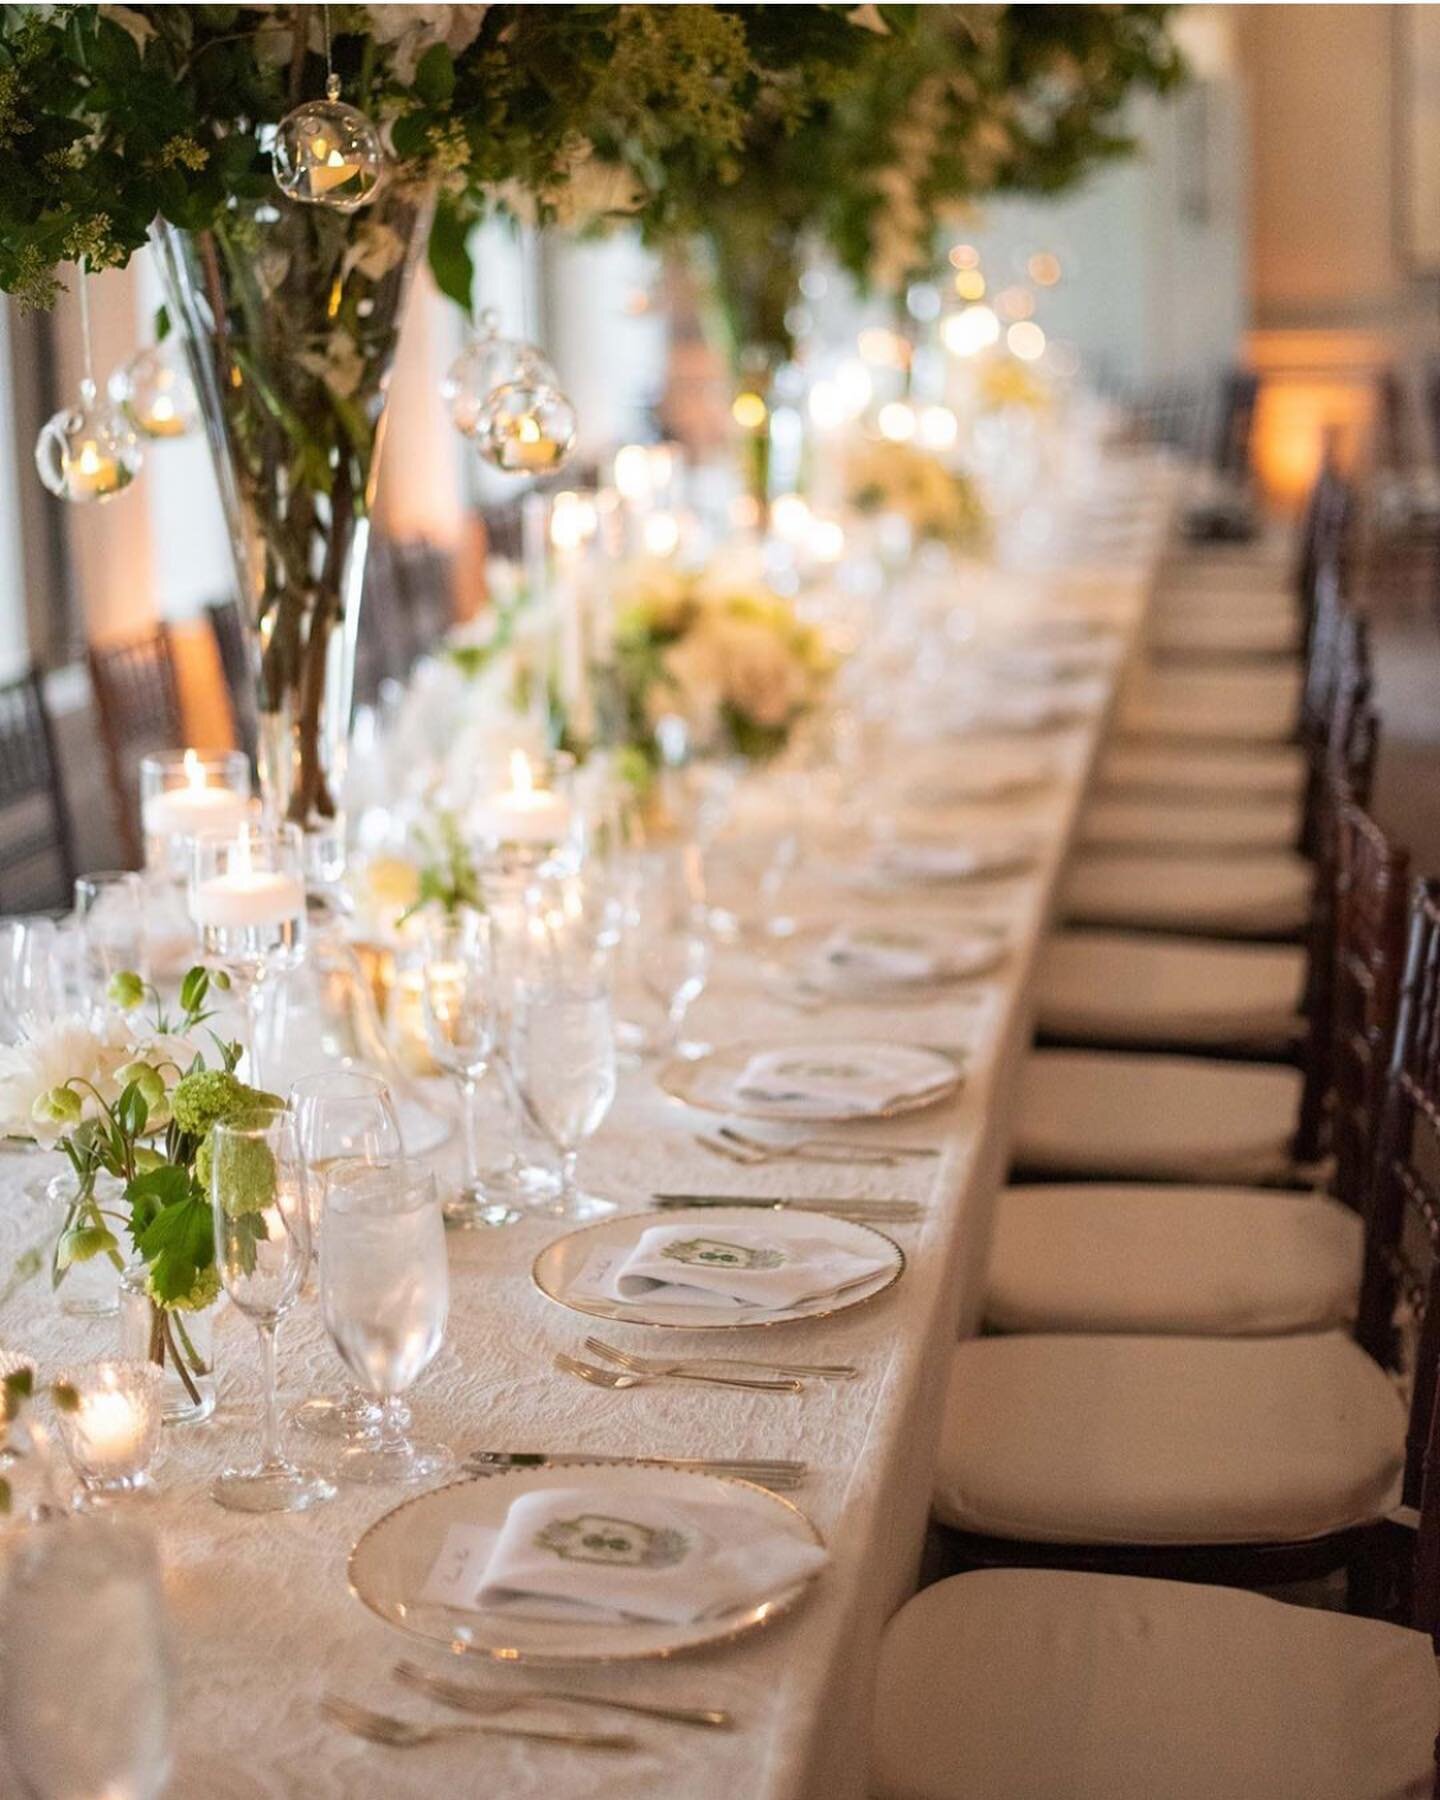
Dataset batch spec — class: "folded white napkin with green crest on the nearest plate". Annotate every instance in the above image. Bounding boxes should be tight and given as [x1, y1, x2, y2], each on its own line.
[475, 1485, 826, 1625]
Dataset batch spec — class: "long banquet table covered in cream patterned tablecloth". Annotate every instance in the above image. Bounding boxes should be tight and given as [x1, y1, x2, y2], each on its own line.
[0, 461, 1175, 1800]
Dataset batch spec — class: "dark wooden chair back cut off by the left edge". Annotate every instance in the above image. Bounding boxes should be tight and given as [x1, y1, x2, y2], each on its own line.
[0, 670, 76, 913]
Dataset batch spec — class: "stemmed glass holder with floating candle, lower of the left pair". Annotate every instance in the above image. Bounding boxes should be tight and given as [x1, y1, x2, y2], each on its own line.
[187, 824, 306, 1087]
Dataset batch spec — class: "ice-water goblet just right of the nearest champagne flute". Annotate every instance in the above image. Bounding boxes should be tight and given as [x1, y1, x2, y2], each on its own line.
[320, 1159, 452, 1481]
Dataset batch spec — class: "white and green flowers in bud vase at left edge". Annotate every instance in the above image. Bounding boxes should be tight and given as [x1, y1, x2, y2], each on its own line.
[0, 967, 281, 1399]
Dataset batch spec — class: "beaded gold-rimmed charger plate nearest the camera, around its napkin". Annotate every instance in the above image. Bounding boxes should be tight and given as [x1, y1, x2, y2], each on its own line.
[347, 1460, 824, 1667]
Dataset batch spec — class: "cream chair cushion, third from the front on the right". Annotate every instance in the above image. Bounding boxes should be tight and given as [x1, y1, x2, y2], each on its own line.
[985, 1183, 1363, 1337]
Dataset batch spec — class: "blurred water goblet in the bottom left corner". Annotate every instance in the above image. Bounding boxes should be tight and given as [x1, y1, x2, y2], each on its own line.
[0, 1517, 171, 1800]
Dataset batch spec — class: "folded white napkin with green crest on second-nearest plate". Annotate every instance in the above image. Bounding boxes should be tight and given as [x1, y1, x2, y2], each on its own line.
[601, 1220, 889, 1312]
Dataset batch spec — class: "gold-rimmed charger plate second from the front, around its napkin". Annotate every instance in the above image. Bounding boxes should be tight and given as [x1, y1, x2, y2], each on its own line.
[529, 1201, 905, 1332]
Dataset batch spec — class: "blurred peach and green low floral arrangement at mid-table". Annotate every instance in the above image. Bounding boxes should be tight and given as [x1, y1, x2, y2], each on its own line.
[601, 563, 835, 776]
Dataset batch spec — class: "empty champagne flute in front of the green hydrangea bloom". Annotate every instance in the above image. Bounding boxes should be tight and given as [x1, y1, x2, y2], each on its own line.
[211, 1107, 335, 1512]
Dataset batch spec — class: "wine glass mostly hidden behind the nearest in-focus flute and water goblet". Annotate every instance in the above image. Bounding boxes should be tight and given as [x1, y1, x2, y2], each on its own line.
[290, 1069, 401, 1442]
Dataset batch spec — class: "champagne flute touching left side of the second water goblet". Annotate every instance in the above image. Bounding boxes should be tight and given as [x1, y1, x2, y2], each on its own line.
[421, 907, 520, 1229]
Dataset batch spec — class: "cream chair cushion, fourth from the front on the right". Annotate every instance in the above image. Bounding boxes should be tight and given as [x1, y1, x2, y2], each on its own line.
[1012, 1049, 1301, 1181]
